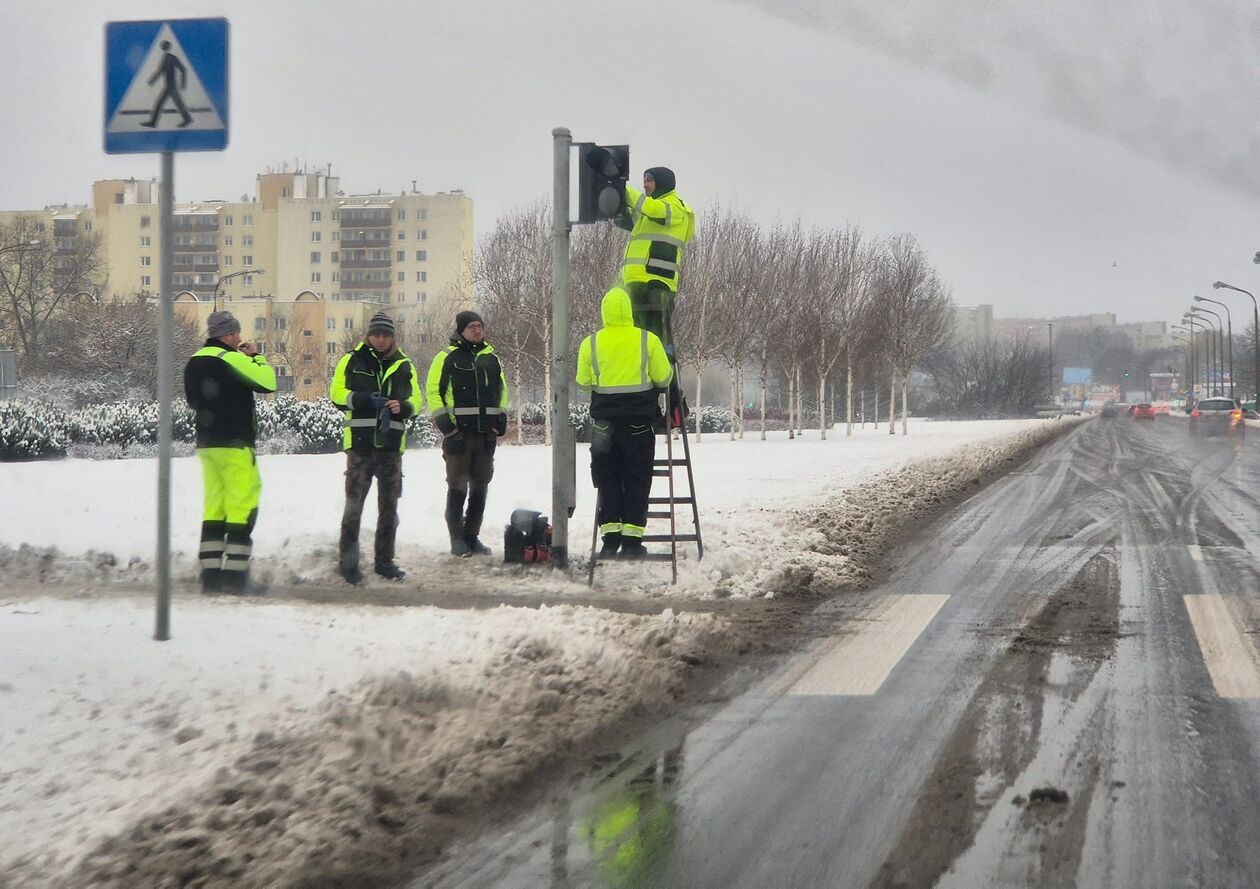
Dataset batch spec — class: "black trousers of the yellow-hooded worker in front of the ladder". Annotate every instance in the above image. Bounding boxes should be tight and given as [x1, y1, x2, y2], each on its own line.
[591, 418, 656, 536]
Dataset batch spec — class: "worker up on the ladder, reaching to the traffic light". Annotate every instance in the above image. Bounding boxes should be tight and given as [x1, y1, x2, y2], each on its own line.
[617, 166, 696, 428]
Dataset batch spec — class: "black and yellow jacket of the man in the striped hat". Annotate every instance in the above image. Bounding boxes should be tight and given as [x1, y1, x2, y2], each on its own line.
[328, 343, 421, 451]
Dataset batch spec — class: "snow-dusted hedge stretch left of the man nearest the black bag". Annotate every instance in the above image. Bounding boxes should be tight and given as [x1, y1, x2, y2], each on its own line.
[0, 395, 437, 461]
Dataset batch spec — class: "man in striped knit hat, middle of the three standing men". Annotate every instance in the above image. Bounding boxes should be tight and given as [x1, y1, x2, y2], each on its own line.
[329, 312, 421, 584]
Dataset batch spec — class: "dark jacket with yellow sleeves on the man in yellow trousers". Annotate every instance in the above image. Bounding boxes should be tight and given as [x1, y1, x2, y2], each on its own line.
[184, 339, 276, 447]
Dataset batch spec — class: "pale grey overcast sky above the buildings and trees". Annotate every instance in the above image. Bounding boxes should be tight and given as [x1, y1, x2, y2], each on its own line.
[0, 0, 1260, 321]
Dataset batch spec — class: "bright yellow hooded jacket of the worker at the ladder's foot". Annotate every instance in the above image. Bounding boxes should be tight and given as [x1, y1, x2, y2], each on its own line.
[577, 287, 674, 419]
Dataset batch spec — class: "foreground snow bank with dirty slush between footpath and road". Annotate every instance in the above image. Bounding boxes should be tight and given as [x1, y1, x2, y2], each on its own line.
[0, 598, 723, 886]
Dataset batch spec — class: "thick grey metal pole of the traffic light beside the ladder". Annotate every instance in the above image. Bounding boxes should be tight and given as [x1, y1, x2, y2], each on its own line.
[551, 127, 577, 568]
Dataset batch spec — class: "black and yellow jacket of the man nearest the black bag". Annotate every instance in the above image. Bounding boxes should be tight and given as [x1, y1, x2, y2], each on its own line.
[425, 336, 508, 436]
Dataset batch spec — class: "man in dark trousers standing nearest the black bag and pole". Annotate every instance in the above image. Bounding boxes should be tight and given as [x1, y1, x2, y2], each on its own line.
[425, 311, 508, 555]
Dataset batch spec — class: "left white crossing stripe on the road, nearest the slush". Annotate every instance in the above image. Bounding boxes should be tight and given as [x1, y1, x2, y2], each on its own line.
[788, 596, 949, 695]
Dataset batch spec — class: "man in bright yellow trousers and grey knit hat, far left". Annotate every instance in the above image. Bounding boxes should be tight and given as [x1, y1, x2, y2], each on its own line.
[184, 311, 276, 593]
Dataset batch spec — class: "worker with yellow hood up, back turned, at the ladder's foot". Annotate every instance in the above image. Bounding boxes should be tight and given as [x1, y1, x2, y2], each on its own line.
[577, 287, 674, 559]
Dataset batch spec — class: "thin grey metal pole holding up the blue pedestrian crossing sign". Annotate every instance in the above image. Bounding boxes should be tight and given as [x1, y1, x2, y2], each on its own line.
[154, 151, 175, 642]
